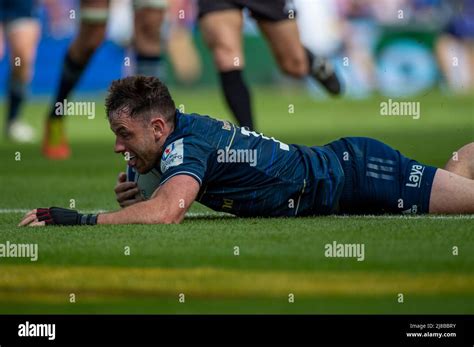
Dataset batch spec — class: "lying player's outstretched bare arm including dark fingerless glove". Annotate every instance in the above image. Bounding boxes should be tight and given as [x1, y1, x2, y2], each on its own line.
[19, 175, 199, 226]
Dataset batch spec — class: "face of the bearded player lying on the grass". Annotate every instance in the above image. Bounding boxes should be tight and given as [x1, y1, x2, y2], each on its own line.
[110, 116, 164, 174]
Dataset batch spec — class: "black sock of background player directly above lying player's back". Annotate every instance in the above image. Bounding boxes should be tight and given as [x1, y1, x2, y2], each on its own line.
[220, 70, 253, 129]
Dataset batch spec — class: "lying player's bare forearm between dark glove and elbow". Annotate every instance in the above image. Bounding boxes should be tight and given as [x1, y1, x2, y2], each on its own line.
[97, 199, 184, 224]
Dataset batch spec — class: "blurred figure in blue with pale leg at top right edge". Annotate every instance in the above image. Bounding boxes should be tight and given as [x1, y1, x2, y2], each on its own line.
[436, 0, 474, 92]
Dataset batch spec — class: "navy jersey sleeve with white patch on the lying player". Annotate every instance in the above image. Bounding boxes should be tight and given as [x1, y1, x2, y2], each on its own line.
[160, 136, 212, 185]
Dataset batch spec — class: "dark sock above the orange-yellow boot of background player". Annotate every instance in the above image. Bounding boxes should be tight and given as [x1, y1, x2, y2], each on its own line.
[49, 52, 87, 119]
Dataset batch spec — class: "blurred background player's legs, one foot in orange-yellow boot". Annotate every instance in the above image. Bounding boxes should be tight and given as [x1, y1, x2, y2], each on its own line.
[43, 0, 167, 159]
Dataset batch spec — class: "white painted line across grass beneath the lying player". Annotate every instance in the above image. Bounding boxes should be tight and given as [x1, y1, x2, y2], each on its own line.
[0, 208, 474, 219]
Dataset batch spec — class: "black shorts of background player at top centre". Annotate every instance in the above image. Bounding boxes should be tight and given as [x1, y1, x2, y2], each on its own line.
[198, 0, 296, 22]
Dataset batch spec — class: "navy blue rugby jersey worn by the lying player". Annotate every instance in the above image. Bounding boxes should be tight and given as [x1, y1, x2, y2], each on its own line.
[156, 111, 344, 216]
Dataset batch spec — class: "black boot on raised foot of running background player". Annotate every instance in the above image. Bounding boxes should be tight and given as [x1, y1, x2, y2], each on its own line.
[305, 48, 341, 95]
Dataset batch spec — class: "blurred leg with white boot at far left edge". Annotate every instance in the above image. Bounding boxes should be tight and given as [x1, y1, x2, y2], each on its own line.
[0, 0, 40, 142]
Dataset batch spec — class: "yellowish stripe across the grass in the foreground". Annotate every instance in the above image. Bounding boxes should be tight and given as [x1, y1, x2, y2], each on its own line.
[0, 265, 474, 299]
